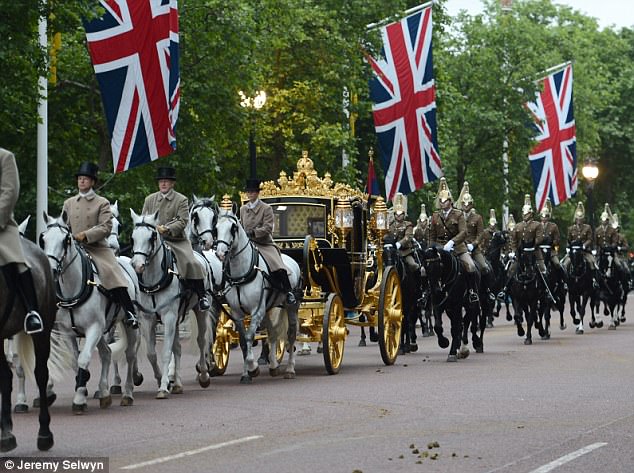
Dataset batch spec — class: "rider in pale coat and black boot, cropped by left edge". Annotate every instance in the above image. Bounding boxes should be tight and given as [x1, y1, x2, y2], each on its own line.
[0, 148, 44, 335]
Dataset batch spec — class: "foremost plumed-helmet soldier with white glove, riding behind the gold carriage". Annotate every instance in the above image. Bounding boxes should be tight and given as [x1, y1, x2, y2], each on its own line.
[429, 177, 479, 303]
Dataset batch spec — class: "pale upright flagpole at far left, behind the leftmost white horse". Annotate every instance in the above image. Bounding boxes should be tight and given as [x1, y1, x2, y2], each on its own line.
[35, 10, 48, 240]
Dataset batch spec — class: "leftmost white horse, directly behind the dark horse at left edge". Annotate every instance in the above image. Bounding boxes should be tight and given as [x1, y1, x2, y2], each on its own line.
[40, 212, 138, 414]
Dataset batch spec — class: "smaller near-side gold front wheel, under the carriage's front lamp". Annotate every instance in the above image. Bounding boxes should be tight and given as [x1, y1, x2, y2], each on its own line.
[321, 293, 348, 374]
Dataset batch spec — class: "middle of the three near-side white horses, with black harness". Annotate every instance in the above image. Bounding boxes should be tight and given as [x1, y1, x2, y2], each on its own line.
[130, 209, 213, 399]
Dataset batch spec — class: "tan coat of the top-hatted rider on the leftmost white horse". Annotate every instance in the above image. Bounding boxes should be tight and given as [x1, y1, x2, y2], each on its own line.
[63, 189, 128, 289]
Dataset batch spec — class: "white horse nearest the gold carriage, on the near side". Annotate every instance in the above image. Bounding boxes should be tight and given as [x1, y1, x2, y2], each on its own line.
[214, 210, 301, 384]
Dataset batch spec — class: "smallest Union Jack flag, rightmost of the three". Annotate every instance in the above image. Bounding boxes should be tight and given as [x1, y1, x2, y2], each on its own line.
[526, 64, 577, 211]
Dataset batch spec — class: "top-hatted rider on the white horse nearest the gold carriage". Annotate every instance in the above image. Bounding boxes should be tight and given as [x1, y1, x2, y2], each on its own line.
[240, 179, 297, 305]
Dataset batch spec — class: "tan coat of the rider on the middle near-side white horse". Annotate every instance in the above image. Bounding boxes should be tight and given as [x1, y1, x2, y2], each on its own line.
[141, 189, 205, 279]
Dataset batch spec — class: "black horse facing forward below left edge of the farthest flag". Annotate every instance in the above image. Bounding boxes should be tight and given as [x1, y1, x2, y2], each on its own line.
[510, 243, 546, 345]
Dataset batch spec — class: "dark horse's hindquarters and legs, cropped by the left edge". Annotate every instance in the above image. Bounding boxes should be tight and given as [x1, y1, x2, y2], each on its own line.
[0, 239, 57, 452]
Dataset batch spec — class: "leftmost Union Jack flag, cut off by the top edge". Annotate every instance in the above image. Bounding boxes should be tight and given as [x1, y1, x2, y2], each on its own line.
[84, 0, 180, 172]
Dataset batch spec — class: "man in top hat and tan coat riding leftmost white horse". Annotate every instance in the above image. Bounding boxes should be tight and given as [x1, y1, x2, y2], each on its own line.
[62, 162, 138, 328]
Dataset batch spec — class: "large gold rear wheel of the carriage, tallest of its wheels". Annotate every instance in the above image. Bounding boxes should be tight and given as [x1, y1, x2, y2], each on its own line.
[378, 266, 403, 365]
